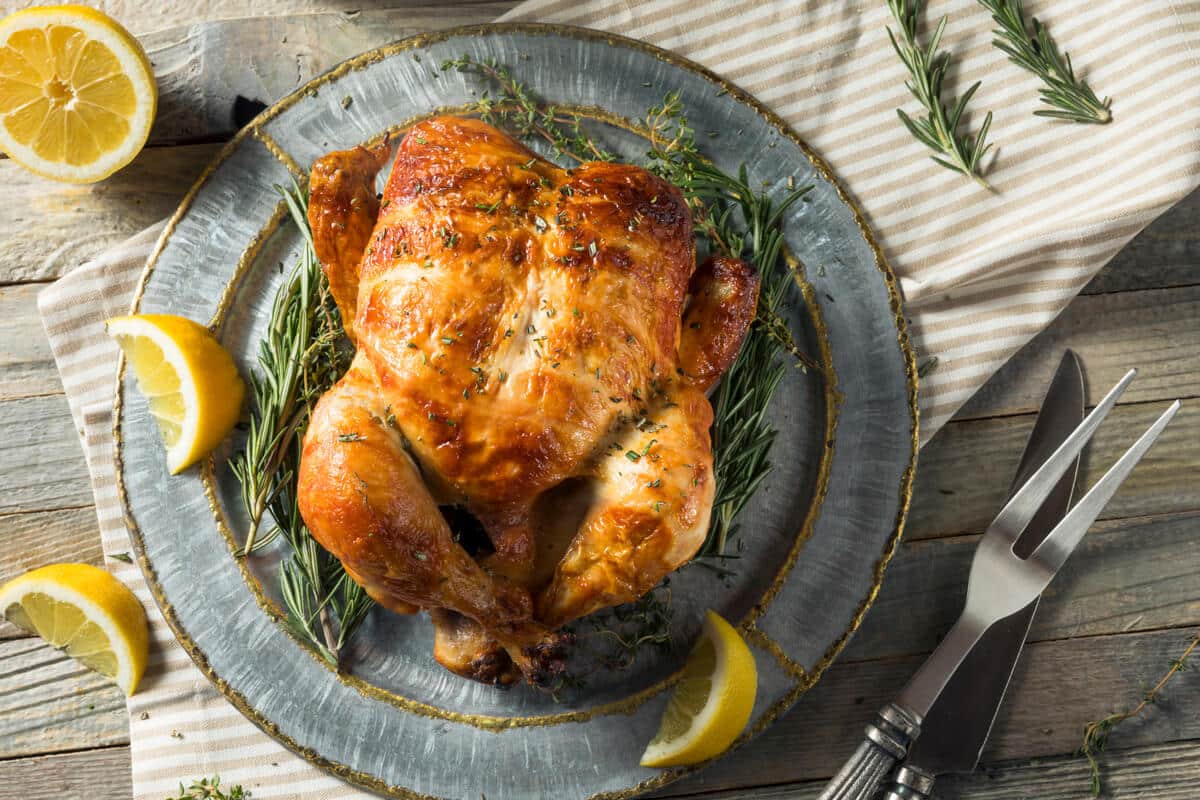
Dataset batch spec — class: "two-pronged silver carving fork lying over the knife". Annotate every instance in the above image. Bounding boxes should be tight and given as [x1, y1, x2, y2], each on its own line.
[821, 369, 1180, 800]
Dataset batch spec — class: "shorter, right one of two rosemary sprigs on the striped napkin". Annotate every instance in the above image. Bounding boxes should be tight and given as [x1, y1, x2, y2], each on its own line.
[979, 0, 1112, 125]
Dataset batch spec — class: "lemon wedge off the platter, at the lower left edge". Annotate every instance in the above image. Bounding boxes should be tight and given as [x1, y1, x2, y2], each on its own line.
[0, 564, 150, 694]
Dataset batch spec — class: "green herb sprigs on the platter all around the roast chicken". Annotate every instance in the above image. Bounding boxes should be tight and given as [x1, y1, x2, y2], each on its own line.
[230, 56, 820, 685]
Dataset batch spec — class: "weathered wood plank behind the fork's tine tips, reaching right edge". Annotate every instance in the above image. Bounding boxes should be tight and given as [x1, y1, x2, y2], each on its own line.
[954, 283, 1200, 421]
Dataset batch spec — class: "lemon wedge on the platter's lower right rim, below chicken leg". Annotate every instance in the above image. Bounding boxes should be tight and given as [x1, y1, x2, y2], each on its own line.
[642, 612, 758, 766]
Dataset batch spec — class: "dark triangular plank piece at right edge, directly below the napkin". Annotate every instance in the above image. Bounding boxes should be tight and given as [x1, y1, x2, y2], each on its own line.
[1084, 190, 1200, 294]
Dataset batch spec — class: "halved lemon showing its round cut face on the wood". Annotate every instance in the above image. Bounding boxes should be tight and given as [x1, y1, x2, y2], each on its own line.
[0, 6, 158, 184]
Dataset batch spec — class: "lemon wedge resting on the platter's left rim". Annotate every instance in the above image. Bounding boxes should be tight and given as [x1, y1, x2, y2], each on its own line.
[107, 314, 246, 475]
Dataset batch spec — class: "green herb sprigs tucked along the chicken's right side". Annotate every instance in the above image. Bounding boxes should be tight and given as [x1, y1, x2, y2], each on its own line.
[646, 92, 817, 557]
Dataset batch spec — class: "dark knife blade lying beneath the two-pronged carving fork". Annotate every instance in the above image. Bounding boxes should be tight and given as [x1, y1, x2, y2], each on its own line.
[901, 350, 1084, 794]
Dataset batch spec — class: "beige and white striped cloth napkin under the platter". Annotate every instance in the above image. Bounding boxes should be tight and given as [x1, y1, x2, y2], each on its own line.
[38, 0, 1200, 800]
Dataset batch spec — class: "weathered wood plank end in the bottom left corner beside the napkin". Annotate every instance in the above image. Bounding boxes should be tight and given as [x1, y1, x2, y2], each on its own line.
[0, 747, 133, 800]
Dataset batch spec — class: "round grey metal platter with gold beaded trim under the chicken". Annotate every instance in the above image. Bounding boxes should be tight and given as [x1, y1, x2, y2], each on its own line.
[115, 24, 917, 800]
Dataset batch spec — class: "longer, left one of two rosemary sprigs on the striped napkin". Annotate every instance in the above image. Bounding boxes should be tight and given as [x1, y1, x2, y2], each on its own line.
[888, 0, 991, 188]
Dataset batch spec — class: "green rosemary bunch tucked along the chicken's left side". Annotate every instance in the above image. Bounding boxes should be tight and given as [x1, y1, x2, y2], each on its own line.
[232, 181, 374, 667]
